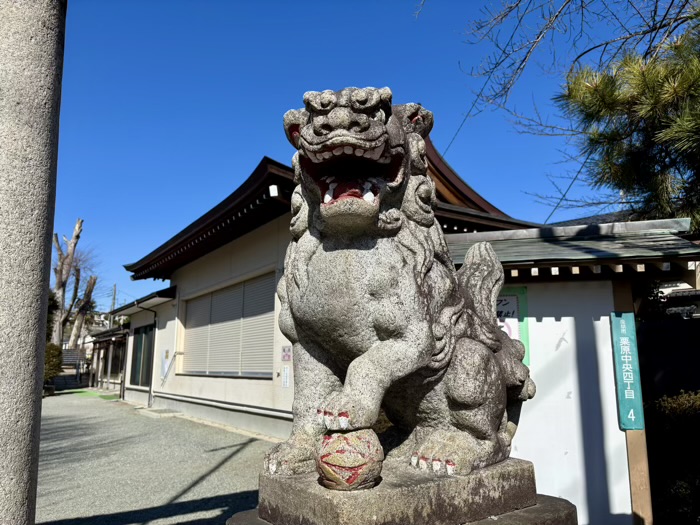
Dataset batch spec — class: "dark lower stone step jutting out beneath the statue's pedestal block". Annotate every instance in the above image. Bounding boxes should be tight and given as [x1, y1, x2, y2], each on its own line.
[226, 494, 578, 525]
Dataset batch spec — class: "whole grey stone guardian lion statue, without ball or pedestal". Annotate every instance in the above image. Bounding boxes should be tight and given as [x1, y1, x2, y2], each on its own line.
[265, 88, 535, 475]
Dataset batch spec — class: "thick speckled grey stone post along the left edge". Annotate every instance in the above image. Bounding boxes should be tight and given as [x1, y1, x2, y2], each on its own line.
[0, 0, 66, 525]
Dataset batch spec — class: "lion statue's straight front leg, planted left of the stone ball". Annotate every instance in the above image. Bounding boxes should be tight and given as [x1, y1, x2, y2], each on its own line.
[264, 343, 342, 476]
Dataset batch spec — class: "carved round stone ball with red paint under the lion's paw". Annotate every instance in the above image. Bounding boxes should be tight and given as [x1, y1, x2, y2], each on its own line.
[316, 429, 384, 490]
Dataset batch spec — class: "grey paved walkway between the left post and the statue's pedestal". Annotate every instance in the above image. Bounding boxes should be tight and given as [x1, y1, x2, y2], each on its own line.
[37, 391, 272, 525]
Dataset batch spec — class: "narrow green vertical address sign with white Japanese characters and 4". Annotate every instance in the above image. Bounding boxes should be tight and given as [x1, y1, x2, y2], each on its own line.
[610, 312, 644, 430]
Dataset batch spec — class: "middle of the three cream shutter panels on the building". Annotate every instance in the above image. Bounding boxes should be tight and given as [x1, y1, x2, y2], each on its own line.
[209, 284, 243, 375]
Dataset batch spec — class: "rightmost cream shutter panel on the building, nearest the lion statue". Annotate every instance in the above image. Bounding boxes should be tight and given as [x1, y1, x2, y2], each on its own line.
[241, 273, 275, 376]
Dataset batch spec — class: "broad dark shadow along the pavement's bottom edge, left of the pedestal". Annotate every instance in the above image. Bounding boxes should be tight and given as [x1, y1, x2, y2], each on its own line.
[42, 490, 258, 525]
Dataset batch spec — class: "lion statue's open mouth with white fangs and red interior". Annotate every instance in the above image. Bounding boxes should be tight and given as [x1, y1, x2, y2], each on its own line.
[300, 137, 404, 206]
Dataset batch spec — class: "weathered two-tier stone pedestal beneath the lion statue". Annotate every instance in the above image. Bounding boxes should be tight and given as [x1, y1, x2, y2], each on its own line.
[226, 459, 576, 525]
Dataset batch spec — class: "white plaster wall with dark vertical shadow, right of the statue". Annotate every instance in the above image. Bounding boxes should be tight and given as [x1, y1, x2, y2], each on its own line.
[513, 282, 632, 525]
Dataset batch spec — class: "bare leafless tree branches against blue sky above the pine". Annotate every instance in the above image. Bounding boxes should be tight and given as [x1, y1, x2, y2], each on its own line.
[462, 0, 698, 106]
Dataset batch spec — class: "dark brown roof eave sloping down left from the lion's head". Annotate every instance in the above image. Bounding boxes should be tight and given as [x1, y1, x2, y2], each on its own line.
[124, 157, 294, 280]
